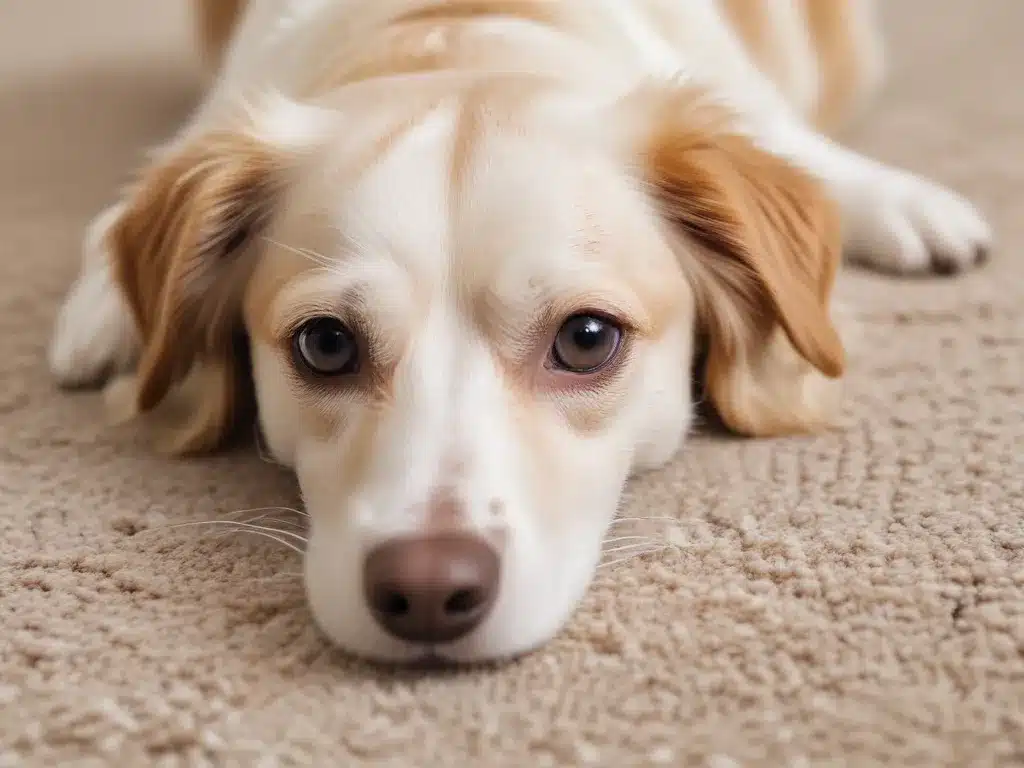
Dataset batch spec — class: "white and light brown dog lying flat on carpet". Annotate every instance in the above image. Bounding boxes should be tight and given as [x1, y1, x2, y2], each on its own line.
[49, 0, 992, 664]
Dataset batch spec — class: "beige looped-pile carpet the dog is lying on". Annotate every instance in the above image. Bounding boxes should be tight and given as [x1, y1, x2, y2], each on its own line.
[0, 0, 1024, 768]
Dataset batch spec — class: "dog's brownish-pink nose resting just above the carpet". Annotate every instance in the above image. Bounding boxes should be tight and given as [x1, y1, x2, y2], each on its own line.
[364, 535, 501, 645]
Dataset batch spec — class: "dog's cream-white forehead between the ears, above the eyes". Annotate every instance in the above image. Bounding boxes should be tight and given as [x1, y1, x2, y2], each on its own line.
[264, 96, 673, 333]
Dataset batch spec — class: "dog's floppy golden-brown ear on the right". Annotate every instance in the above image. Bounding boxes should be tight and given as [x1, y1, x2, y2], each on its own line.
[643, 87, 845, 435]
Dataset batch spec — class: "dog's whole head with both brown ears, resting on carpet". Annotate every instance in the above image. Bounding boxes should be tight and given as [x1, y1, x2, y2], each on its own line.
[103, 84, 842, 662]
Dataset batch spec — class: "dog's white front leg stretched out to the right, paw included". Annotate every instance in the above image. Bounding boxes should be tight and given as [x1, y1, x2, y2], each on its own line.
[650, 0, 991, 272]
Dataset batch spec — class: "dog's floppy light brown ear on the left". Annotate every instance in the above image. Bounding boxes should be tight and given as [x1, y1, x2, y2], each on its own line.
[109, 133, 282, 455]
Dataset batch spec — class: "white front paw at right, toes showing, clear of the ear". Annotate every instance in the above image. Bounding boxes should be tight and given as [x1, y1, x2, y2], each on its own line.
[841, 168, 992, 274]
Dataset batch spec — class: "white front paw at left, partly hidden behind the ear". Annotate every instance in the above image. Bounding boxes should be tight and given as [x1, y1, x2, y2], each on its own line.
[48, 207, 138, 387]
